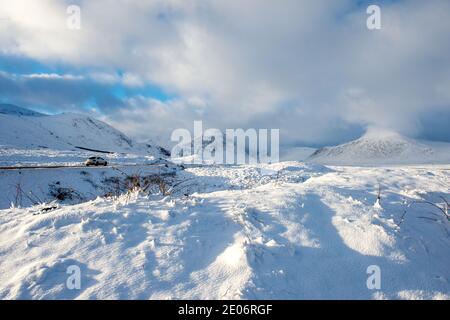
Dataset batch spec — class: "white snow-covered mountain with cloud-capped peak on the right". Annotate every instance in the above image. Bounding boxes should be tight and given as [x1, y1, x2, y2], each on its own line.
[307, 129, 450, 165]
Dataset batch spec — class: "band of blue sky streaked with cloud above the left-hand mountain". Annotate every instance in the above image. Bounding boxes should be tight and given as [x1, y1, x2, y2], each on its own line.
[0, 54, 175, 114]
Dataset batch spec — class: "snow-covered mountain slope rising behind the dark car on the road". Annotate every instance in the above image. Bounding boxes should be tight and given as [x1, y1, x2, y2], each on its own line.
[0, 105, 167, 156]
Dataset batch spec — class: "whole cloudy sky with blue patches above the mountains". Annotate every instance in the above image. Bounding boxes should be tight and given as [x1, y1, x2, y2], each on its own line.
[0, 0, 450, 146]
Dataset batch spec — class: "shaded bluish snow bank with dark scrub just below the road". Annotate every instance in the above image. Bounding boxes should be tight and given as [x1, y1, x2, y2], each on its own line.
[0, 161, 179, 209]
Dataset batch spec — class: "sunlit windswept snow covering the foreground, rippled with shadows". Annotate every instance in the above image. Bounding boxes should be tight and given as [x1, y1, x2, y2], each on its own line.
[0, 162, 450, 299]
